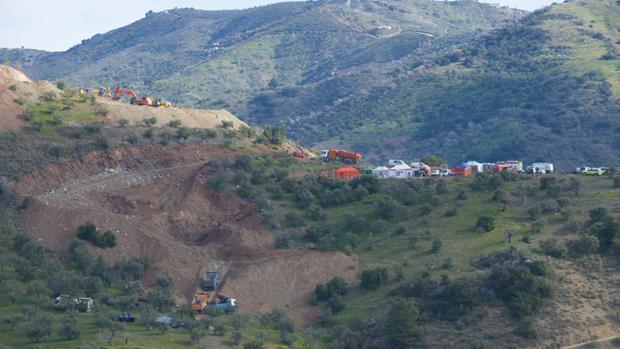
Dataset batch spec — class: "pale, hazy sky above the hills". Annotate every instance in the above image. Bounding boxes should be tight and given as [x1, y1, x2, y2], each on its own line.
[0, 0, 553, 51]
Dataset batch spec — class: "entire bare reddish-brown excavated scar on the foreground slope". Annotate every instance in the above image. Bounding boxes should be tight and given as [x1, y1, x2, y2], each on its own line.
[12, 144, 357, 323]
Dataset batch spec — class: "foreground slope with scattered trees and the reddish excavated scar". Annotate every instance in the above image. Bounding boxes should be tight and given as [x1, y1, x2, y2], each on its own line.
[0, 74, 620, 349]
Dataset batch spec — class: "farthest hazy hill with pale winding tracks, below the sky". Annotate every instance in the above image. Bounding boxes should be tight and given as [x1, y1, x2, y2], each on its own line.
[0, 0, 524, 135]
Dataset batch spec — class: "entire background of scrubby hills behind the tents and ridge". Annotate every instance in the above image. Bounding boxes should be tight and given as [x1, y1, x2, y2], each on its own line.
[0, 0, 620, 169]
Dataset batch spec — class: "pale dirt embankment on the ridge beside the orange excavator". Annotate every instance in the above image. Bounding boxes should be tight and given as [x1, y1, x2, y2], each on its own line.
[98, 98, 247, 128]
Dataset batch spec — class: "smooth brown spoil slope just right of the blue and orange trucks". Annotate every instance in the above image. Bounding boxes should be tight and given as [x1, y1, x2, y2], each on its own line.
[222, 251, 358, 324]
